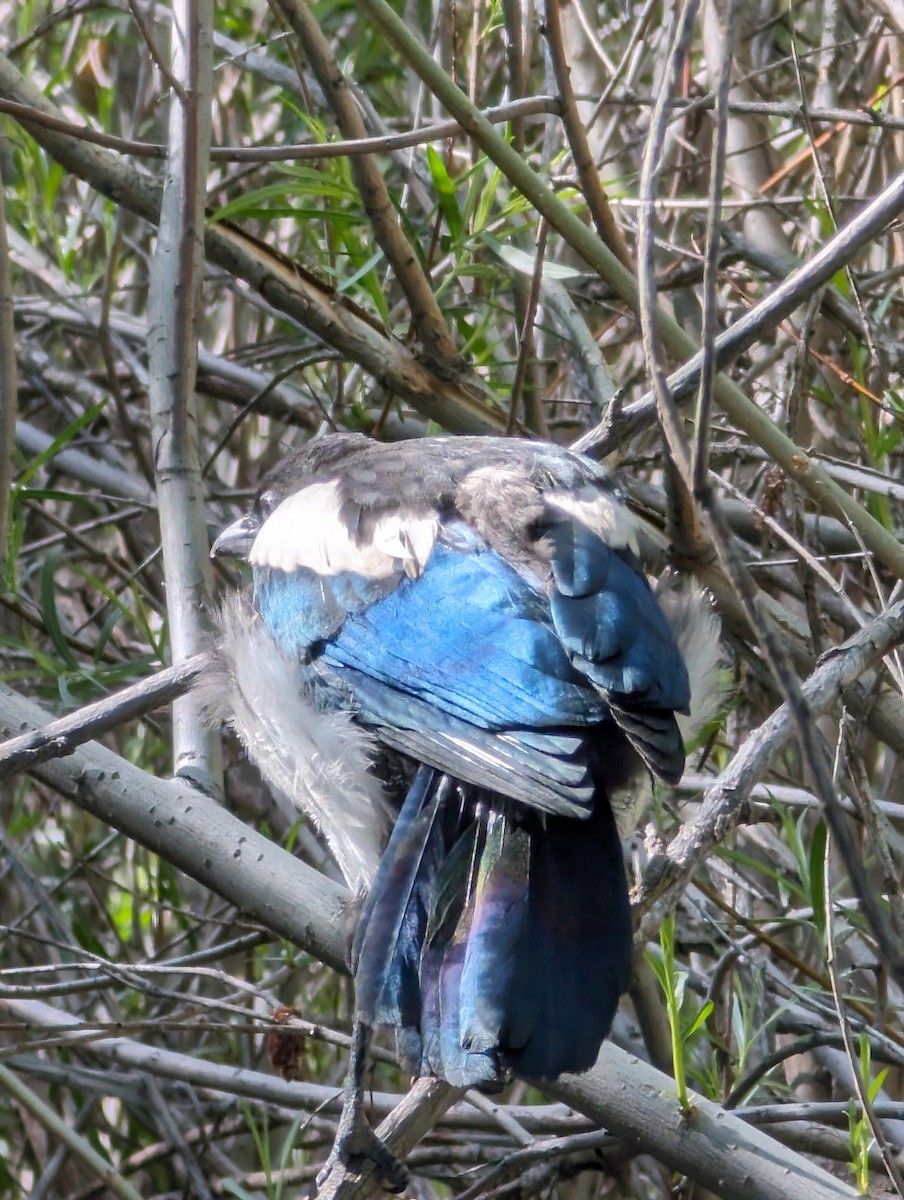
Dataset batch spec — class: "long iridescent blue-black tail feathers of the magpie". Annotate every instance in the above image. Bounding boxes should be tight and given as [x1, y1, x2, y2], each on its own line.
[355, 768, 631, 1088]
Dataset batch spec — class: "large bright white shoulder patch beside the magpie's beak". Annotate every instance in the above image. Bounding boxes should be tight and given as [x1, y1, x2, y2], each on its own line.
[249, 481, 439, 580]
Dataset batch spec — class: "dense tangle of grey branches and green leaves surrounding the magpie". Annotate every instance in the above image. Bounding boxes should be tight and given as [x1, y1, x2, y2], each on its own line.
[0, 0, 904, 1200]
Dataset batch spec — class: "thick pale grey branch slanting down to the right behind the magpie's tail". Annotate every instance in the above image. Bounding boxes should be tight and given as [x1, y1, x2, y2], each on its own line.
[0, 688, 855, 1200]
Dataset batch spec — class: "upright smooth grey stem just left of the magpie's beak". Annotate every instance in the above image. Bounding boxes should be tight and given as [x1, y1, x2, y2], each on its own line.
[148, 0, 222, 793]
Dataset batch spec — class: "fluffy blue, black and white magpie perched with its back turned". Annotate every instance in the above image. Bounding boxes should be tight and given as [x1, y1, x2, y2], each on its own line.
[208, 433, 718, 1171]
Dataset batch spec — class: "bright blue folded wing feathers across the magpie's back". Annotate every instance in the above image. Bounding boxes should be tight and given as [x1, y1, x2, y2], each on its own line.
[250, 506, 689, 811]
